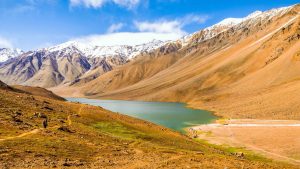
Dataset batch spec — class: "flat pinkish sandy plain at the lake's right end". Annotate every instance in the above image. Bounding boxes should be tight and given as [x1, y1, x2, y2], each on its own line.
[188, 119, 300, 165]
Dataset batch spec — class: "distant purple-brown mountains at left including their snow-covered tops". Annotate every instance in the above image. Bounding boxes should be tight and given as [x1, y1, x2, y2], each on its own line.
[0, 41, 165, 88]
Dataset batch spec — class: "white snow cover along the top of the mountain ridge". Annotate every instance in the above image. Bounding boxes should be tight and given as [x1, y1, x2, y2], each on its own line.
[0, 6, 293, 63]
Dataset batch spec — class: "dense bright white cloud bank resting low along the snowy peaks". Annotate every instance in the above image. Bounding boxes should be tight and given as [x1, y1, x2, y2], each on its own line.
[72, 32, 183, 46]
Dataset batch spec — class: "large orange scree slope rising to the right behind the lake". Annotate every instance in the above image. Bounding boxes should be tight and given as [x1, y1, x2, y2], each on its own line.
[57, 5, 300, 119]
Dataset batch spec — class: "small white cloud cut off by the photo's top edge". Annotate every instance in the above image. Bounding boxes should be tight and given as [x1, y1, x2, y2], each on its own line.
[69, 0, 140, 9]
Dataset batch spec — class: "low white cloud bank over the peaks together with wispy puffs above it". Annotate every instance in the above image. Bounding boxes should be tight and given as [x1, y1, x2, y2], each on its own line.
[63, 15, 208, 46]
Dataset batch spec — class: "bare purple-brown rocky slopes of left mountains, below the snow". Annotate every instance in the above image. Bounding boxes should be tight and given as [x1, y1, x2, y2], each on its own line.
[0, 47, 122, 87]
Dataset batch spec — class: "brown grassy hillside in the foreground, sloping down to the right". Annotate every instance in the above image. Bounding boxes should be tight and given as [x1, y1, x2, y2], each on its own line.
[0, 83, 296, 168]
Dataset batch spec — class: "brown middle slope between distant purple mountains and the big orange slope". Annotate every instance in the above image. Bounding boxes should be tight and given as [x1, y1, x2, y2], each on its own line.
[51, 42, 182, 96]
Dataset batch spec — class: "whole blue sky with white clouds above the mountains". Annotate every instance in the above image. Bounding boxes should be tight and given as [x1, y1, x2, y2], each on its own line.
[0, 0, 299, 50]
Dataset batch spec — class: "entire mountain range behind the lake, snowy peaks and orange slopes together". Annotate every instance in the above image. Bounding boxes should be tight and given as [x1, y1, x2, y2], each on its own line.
[0, 5, 300, 119]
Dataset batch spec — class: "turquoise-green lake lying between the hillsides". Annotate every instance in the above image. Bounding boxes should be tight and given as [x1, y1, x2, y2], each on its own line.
[67, 98, 216, 132]
